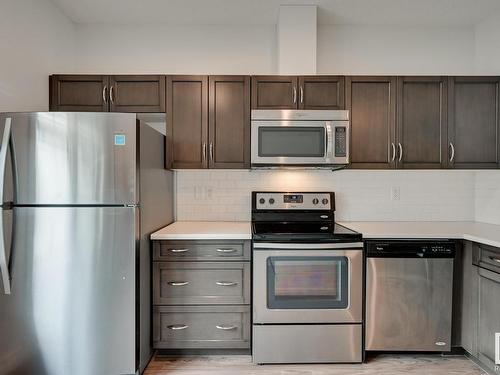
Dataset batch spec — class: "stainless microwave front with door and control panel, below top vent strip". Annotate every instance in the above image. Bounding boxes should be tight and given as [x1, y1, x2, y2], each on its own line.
[251, 120, 349, 166]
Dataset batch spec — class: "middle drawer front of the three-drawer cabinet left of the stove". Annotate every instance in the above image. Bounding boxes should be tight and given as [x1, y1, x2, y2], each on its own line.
[153, 262, 250, 305]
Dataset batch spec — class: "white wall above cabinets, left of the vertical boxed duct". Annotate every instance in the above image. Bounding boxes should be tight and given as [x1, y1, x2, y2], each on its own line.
[76, 25, 277, 74]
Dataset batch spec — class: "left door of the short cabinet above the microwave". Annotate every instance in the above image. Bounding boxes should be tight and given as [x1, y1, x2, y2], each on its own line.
[252, 76, 298, 109]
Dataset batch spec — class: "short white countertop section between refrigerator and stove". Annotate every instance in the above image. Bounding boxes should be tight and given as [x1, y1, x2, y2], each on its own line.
[147, 221, 252, 240]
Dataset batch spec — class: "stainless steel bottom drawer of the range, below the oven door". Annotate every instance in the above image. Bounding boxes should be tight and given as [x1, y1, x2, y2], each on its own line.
[252, 324, 362, 363]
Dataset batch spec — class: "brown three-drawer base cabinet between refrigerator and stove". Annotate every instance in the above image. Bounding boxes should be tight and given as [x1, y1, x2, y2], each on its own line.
[153, 240, 251, 349]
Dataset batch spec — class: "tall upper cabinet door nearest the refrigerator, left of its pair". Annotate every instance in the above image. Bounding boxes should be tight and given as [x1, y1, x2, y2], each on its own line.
[167, 76, 208, 168]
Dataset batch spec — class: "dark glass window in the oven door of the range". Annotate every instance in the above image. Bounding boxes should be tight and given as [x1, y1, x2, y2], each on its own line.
[267, 256, 349, 309]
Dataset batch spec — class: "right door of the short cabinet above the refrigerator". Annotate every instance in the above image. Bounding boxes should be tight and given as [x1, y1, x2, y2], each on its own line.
[109, 75, 165, 112]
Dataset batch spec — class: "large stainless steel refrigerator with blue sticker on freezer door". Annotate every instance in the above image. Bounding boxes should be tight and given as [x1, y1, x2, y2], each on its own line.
[0, 112, 173, 375]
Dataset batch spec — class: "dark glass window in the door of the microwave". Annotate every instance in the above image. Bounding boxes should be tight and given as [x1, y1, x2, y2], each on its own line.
[259, 126, 325, 158]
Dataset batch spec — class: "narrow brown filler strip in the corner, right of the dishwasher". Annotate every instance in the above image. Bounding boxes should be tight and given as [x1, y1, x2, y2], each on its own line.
[460, 241, 479, 356]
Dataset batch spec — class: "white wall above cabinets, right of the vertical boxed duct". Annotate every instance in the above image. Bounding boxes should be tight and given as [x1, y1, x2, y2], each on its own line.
[318, 25, 474, 75]
